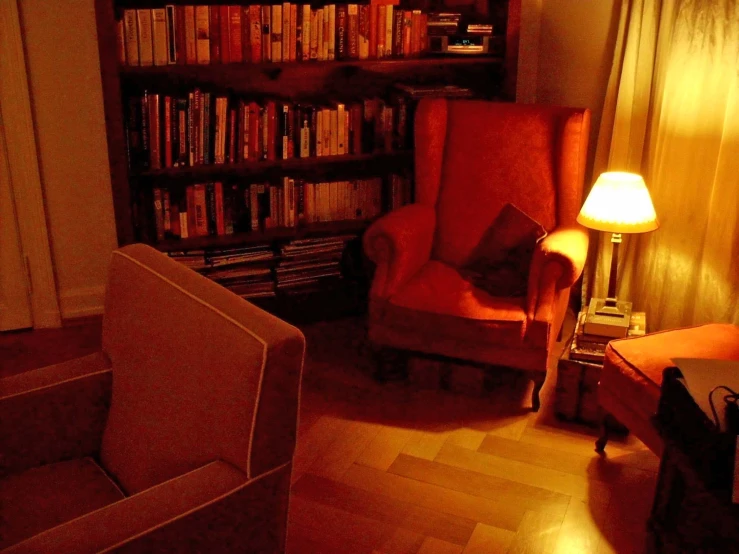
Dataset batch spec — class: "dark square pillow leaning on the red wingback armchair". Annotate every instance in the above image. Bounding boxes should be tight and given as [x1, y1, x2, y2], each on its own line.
[460, 203, 547, 297]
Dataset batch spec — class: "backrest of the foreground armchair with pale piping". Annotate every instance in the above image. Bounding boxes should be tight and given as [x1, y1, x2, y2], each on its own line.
[101, 244, 305, 494]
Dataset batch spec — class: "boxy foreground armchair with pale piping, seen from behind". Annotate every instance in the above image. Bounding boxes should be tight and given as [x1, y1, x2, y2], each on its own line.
[0, 245, 305, 554]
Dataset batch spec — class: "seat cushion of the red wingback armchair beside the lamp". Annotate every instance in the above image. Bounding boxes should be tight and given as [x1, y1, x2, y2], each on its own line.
[380, 261, 526, 348]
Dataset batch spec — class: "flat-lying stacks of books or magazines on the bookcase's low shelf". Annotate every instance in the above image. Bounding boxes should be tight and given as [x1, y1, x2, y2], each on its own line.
[169, 235, 356, 298]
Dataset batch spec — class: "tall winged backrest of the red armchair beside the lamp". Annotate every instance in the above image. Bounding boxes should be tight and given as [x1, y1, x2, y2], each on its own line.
[415, 99, 590, 266]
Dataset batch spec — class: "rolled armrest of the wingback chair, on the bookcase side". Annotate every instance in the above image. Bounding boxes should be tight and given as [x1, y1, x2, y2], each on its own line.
[363, 204, 436, 298]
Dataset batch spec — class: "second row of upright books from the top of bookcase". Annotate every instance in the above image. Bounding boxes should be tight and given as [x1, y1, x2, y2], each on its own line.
[125, 89, 411, 171]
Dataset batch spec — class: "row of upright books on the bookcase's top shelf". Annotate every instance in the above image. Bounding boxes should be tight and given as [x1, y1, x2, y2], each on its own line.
[117, 2, 428, 66]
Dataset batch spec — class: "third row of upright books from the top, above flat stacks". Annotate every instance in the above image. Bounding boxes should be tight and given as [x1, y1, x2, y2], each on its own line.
[153, 175, 411, 240]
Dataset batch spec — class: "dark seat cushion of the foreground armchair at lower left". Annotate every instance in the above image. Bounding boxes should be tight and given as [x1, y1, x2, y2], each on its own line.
[0, 452, 124, 550]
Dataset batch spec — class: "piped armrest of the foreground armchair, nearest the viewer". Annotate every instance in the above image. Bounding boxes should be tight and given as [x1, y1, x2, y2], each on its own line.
[3, 460, 290, 554]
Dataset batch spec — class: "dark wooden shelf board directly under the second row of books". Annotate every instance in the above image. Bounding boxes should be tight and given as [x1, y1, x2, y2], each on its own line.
[131, 150, 413, 184]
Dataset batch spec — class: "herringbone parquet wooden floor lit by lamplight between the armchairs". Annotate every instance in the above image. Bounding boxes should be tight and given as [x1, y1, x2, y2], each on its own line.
[0, 312, 658, 554]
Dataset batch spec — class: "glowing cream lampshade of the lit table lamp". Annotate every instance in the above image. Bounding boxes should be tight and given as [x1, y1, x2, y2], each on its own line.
[577, 171, 659, 233]
